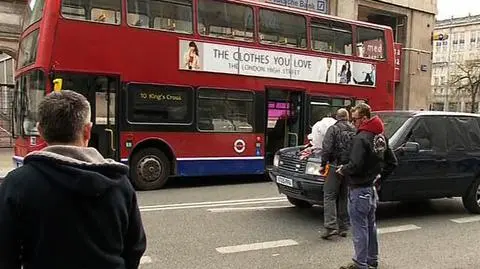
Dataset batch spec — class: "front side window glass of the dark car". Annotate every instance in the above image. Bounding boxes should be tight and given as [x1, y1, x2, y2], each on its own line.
[407, 117, 447, 152]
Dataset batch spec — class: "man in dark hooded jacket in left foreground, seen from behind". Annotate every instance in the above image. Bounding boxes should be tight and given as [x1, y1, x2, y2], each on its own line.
[0, 91, 146, 269]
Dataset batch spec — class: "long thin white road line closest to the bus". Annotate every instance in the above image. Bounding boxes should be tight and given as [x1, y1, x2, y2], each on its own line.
[139, 196, 287, 212]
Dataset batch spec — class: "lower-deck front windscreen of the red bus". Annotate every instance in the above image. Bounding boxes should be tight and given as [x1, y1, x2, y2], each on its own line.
[14, 70, 45, 136]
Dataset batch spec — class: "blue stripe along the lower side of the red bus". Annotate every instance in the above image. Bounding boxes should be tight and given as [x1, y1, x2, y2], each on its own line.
[177, 158, 265, 177]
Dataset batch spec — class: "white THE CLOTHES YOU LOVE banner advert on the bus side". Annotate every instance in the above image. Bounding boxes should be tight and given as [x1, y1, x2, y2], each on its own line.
[179, 40, 375, 86]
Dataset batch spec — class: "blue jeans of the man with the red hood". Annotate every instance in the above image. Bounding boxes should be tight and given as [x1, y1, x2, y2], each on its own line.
[348, 187, 378, 269]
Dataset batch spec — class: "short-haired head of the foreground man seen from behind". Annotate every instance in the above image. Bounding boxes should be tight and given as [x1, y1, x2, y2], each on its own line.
[38, 90, 91, 144]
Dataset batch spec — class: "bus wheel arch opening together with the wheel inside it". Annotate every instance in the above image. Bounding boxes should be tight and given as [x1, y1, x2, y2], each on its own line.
[129, 139, 175, 190]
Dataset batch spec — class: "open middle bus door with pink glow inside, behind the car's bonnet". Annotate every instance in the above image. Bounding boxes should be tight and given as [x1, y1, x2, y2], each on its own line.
[265, 89, 305, 166]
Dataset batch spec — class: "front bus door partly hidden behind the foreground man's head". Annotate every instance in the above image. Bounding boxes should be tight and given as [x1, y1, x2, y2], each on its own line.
[50, 73, 120, 159]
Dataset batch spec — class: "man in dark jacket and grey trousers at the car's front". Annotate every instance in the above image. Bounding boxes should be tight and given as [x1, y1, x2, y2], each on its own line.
[320, 108, 355, 239]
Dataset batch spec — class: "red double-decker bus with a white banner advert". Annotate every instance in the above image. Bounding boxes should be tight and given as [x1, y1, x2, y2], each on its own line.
[14, 0, 394, 190]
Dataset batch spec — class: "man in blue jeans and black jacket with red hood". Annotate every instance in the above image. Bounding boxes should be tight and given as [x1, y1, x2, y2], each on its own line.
[337, 104, 397, 269]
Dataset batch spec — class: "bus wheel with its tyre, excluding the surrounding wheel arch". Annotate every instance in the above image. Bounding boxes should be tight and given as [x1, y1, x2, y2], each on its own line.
[131, 148, 170, 190]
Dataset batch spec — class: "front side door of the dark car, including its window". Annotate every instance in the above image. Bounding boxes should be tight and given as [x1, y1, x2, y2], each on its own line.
[389, 116, 448, 200]
